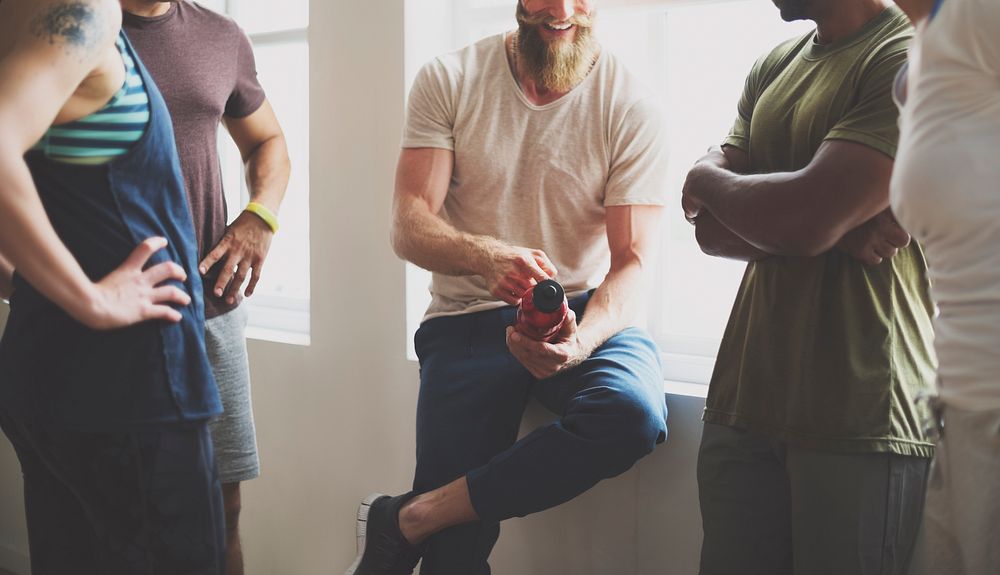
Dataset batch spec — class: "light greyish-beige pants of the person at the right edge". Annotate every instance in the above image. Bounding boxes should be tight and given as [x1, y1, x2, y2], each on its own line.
[913, 407, 1000, 575]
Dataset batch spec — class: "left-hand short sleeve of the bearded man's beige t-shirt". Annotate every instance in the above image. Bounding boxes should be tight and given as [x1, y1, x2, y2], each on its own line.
[403, 60, 457, 150]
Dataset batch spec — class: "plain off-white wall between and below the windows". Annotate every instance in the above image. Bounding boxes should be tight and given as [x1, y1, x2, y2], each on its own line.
[0, 0, 704, 575]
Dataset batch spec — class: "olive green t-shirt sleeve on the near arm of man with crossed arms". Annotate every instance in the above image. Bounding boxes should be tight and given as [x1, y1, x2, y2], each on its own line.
[824, 36, 909, 158]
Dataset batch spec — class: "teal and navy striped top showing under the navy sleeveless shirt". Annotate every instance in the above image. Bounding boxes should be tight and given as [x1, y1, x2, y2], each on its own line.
[32, 34, 149, 165]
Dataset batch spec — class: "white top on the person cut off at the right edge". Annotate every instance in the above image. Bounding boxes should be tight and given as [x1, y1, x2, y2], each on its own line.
[891, 0, 1000, 409]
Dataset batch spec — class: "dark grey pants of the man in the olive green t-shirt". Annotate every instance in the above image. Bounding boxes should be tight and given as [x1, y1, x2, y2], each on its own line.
[698, 424, 929, 575]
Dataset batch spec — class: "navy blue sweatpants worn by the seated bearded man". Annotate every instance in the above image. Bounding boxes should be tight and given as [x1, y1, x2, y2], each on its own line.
[413, 295, 667, 575]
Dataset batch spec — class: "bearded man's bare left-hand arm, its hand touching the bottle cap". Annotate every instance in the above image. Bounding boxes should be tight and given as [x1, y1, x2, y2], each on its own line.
[391, 148, 556, 305]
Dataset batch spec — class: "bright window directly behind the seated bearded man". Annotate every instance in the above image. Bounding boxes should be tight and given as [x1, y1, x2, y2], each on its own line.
[407, 0, 812, 384]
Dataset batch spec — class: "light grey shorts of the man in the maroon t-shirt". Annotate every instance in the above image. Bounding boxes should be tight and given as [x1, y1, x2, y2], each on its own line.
[205, 306, 260, 483]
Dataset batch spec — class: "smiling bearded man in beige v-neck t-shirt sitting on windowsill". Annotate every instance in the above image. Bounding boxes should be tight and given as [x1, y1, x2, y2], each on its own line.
[347, 0, 667, 575]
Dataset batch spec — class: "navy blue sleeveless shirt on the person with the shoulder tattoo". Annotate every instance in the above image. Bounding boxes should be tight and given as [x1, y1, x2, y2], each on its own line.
[0, 30, 222, 431]
